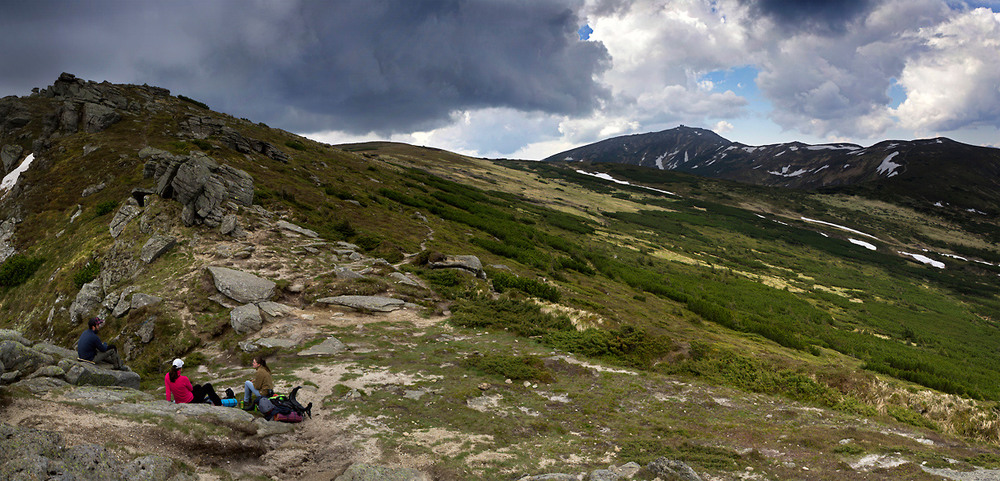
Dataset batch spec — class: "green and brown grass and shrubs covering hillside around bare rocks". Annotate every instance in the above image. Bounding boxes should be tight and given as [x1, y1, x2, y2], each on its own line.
[0, 86, 1000, 476]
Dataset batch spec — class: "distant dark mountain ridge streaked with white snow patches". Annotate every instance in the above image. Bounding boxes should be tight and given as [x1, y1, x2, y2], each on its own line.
[543, 126, 1000, 215]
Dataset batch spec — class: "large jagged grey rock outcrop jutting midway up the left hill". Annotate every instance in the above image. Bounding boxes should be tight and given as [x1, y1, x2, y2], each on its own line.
[139, 147, 253, 227]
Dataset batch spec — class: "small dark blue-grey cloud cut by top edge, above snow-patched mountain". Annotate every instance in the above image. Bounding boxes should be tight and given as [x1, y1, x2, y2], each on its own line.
[743, 0, 878, 34]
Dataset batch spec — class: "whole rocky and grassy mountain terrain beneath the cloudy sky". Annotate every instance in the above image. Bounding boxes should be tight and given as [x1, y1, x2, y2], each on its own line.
[0, 74, 1000, 481]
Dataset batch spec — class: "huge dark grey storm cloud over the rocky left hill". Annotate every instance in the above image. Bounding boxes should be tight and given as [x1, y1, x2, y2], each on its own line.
[0, 0, 610, 133]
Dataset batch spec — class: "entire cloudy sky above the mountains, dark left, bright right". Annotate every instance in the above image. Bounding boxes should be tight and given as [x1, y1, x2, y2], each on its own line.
[0, 0, 1000, 159]
